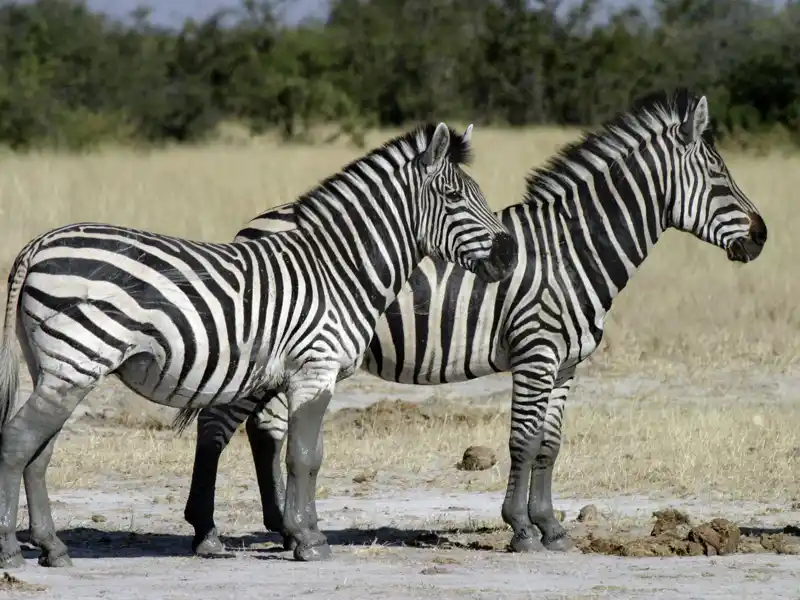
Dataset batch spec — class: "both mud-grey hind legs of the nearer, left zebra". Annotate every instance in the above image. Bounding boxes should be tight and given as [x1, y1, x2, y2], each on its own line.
[0, 376, 91, 568]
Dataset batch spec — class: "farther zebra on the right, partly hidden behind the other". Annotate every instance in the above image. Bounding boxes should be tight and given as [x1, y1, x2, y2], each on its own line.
[186, 88, 767, 552]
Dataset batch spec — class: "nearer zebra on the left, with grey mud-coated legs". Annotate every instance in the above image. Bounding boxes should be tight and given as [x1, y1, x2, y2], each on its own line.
[0, 123, 517, 567]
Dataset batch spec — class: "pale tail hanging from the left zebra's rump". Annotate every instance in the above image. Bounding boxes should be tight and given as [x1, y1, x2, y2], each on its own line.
[0, 254, 29, 427]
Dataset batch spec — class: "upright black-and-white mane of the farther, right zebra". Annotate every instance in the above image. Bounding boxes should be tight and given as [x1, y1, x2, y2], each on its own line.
[523, 88, 714, 210]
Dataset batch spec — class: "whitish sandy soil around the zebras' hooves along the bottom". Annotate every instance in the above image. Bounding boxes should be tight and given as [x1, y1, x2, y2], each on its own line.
[0, 482, 800, 600]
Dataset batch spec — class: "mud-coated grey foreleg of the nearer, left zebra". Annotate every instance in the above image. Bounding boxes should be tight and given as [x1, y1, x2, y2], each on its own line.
[283, 379, 335, 561]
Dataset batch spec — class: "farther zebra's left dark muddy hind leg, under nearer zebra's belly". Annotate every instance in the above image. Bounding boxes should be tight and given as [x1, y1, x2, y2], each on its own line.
[183, 398, 257, 556]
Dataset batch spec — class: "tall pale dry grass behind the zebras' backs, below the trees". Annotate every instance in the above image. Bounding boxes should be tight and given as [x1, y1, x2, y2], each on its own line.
[0, 127, 800, 372]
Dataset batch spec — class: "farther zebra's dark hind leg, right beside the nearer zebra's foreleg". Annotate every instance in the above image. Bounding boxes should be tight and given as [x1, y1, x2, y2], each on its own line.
[246, 392, 296, 550]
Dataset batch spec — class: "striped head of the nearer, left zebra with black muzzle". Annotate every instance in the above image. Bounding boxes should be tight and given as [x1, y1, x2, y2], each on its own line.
[417, 123, 518, 283]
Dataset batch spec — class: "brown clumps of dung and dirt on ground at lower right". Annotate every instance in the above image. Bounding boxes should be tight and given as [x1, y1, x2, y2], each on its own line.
[576, 509, 800, 557]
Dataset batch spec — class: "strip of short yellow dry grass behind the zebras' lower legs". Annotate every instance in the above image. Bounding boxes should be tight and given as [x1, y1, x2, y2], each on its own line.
[49, 396, 800, 502]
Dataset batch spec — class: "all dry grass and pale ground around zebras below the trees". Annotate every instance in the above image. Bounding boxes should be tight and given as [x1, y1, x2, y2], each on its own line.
[0, 127, 800, 599]
